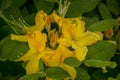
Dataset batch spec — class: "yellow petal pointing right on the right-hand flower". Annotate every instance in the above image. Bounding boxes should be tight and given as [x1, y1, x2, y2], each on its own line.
[76, 31, 103, 46]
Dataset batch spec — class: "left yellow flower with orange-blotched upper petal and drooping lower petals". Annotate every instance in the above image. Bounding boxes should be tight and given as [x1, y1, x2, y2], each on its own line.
[18, 31, 47, 74]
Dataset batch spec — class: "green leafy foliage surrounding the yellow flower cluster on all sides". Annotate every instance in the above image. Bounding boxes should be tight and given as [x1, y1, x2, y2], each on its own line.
[0, 0, 120, 80]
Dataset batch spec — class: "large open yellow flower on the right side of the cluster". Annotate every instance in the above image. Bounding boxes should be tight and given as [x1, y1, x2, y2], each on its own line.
[58, 18, 103, 61]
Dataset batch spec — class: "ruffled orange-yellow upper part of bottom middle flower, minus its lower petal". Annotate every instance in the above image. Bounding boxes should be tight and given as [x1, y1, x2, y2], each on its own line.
[42, 45, 73, 67]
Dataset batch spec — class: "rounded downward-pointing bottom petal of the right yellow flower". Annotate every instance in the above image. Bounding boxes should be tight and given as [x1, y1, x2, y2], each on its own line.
[74, 46, 88, 61]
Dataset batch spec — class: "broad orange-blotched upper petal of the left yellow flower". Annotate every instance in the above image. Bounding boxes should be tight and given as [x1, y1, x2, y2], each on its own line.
[27, 30, 47, 52]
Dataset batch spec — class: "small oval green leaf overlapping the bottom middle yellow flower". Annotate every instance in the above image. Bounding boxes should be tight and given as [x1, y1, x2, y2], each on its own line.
[64, 57, 82, 67]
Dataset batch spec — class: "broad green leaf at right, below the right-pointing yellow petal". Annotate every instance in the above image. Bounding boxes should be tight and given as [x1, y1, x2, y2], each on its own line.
[86, 40, 117, 61]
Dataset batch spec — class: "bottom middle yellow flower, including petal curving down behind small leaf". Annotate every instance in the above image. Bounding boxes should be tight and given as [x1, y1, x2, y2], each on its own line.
[43, 45, 76, 80]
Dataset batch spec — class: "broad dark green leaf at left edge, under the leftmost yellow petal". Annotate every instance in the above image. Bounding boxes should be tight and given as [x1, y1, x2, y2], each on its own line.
[0, 37, 28, 60]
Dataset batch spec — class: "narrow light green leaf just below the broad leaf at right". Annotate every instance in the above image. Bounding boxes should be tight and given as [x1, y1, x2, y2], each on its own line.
[85, 59, 110, 67]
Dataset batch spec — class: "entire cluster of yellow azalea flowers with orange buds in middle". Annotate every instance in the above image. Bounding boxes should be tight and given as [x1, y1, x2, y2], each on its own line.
[11, 10, 103, 80]
